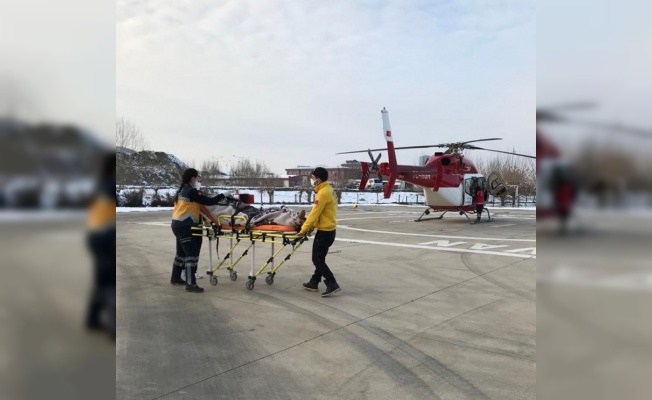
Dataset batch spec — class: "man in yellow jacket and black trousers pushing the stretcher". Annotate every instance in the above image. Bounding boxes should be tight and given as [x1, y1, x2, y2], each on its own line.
[299, 167, 340, 297]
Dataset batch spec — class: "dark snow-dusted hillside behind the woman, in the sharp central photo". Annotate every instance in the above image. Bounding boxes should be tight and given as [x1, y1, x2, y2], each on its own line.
[116, 149, 188, 186]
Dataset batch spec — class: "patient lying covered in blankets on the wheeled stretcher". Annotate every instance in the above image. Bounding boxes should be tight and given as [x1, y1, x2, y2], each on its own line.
[204, 197, 306, 232]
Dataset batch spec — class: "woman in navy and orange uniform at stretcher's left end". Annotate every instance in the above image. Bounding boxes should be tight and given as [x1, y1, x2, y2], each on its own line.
[170, 168, 225, 293]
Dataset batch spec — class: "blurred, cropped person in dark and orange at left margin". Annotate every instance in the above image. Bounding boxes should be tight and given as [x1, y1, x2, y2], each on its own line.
[86, 153, 117, 340]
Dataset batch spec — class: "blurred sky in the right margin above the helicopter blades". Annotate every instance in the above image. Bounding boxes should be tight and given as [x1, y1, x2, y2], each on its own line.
[537, 0, 652, 152]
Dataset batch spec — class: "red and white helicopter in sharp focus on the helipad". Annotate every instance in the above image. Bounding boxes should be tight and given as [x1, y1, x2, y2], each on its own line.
[336, 108, 536, 223]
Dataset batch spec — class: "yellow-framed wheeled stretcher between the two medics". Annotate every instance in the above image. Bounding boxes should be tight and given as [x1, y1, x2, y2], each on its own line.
[192, 207, 308, 290]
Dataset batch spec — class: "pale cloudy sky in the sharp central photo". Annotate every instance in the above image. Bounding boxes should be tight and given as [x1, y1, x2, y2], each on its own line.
[116, 0, 536, 174]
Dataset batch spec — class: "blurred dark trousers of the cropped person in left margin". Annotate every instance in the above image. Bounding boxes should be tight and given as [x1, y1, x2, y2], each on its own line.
[86, 228, 116, 337]
